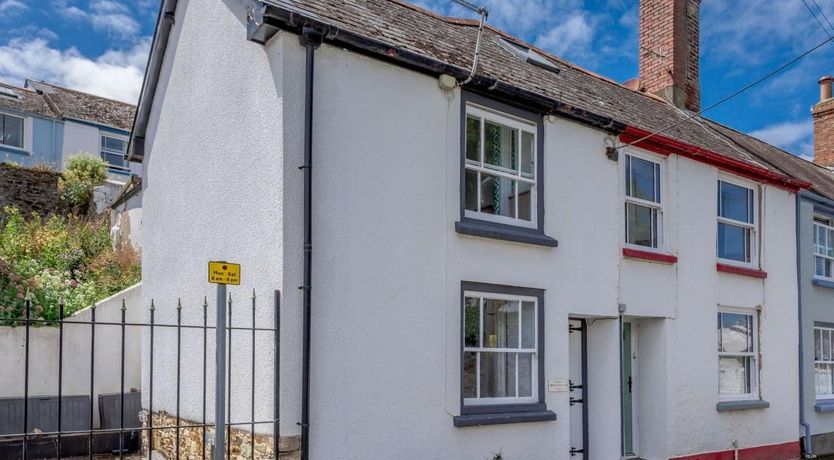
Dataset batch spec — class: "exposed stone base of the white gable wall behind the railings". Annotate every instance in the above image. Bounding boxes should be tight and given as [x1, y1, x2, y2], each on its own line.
[142, 412, 301, 460]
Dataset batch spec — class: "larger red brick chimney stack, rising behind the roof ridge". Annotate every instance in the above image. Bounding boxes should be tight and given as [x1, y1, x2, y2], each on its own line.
[640, 0, 701, 112]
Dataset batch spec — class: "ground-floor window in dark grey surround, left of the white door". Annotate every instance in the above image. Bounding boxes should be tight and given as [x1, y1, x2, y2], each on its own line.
[461, 283, 544, 408]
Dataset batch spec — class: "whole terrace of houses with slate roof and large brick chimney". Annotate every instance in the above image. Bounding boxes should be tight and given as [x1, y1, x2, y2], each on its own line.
[128, 0, 834, 460]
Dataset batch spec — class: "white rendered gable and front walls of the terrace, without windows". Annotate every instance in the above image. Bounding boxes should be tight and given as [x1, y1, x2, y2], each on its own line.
[138, 0, 796, 460]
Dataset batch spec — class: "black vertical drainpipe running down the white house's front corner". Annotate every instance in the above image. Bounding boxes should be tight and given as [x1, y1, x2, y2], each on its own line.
[298, 25, 324, 460]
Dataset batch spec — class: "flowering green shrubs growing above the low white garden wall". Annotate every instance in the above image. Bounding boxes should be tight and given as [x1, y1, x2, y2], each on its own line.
[0, 208, 141, 325]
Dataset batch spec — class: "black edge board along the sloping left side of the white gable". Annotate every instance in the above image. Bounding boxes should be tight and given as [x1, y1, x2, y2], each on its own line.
[125, 0, 179, 162]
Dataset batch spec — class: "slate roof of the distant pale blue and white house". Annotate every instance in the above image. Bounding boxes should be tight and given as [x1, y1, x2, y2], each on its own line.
[0, 80, 136, 131]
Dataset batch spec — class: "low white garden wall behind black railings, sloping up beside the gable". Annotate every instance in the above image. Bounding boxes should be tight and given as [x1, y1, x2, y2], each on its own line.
[0, 284, 144, 426]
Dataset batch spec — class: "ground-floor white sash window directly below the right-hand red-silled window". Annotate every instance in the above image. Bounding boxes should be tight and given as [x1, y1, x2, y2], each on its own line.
[718, 309, 758, 400]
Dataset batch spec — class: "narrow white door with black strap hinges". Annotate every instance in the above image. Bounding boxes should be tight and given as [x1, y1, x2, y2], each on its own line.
[568, 320, 586, 460]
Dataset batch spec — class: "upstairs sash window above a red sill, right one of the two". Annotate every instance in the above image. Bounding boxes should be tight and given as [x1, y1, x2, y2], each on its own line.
[718, 180, 756, 265]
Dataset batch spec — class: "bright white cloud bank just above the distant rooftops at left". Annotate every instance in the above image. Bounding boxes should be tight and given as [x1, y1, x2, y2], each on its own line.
[0, 37, 151, 104]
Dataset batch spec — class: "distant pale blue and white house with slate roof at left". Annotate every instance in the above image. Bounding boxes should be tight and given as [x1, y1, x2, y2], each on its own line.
[0, 80, 140, 184]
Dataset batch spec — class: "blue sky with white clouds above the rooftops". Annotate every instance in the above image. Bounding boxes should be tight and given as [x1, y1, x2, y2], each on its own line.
[0, 0, 834, 160]
